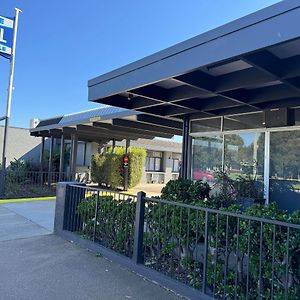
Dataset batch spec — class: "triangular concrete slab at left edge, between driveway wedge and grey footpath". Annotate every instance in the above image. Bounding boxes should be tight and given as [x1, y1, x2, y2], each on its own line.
[0, 205, 51, 241]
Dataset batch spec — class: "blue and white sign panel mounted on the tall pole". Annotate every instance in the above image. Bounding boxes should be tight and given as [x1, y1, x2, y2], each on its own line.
[0, 16, 14, 58]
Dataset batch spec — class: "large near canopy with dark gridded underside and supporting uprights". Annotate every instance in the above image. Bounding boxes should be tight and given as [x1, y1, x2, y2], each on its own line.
[88, 0, 300, 209]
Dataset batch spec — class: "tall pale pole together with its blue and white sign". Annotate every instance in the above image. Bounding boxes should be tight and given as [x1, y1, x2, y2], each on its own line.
[0, 8, 22, 194]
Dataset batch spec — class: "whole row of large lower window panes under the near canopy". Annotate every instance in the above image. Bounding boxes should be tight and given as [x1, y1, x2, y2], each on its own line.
[192, 121, 300, 211]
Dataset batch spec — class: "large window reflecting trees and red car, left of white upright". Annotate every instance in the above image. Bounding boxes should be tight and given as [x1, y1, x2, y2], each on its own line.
[192, 133, 265, 185]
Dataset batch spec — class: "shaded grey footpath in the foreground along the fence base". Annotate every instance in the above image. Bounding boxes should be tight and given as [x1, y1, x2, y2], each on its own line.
[0, 234, 182, 300]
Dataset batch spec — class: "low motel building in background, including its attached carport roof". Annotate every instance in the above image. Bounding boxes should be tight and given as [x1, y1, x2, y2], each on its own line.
[29, 106, 182, 185]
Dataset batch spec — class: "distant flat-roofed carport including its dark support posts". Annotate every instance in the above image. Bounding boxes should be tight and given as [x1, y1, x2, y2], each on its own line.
[30, 106, 182, 180]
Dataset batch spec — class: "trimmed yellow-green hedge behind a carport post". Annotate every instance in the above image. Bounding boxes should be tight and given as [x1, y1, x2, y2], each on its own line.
[91, 147, 146, 188]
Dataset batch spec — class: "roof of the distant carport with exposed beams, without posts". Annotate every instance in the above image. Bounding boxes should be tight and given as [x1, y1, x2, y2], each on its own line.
[30, 107, 182, 143]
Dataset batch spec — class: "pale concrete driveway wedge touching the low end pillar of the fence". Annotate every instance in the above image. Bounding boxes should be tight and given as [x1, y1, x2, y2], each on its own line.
[0, 200, 55, 231]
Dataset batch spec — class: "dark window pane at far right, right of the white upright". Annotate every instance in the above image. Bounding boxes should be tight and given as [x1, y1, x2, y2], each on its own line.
[270, 130, 300, 210]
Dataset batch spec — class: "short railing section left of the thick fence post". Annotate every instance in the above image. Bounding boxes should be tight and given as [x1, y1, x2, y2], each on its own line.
[64, 185, 137, 257]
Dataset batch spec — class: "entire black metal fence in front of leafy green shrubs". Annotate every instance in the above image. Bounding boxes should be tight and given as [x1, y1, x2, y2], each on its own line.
[64, 185, 300, 299]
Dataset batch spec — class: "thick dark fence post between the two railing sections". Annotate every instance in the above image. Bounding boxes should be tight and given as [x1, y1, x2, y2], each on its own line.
[132, 192, 146, 264]
